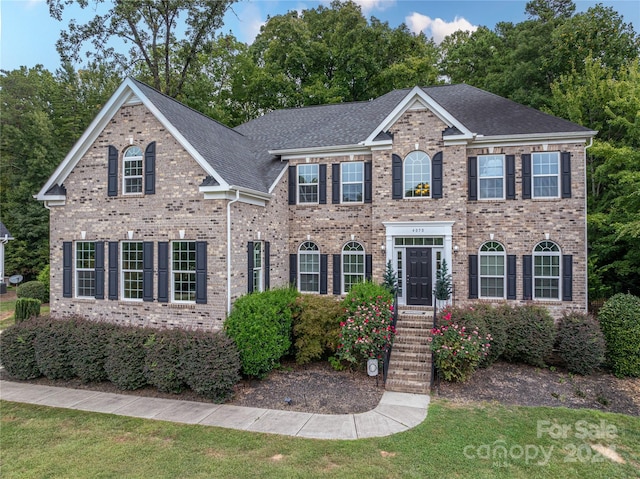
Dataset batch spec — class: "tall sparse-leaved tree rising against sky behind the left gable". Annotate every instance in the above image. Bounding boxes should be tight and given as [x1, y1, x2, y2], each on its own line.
[47, 0, 236, 97]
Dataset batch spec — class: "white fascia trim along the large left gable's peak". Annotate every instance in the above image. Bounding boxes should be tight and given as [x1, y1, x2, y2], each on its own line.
[35, 78, 228, 201]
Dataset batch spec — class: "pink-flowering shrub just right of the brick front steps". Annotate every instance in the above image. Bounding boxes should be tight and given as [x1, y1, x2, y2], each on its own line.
[429, 313, 491, 382]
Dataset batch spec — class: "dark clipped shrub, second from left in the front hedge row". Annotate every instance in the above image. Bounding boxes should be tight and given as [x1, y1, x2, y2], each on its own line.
[33, 319, 75, 379]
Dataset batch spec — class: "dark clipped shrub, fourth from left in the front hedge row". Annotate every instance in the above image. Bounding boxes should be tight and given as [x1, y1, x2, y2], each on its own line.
[104, 326, 150, 389]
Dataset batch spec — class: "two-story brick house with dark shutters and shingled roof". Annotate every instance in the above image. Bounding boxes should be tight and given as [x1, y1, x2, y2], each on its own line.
[37, 79, 595, 329]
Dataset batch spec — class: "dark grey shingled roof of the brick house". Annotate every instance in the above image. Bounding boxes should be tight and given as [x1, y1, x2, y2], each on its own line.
[133, 79, 590, 192]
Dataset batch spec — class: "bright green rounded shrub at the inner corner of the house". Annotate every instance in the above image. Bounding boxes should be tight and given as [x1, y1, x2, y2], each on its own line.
[224, 288, 298, 378]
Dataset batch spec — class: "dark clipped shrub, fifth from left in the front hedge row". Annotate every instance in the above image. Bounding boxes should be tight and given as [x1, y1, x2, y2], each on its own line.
[144, 329, 186, 394]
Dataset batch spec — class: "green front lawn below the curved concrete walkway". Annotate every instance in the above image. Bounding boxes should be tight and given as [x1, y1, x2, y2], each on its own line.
[0, 400, 640, 479]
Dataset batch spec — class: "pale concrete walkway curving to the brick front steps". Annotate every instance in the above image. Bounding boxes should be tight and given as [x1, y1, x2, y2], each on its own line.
[0, 381, 429, 439]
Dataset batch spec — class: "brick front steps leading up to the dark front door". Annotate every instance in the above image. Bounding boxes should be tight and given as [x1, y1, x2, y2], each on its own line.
[385, 306, 433, 394]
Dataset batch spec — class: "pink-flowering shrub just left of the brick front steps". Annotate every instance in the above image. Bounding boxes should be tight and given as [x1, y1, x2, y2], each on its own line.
[336, 283, 395, 364]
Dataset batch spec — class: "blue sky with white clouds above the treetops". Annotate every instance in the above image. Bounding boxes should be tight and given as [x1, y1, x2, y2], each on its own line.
[0, 0, 640, 71]
